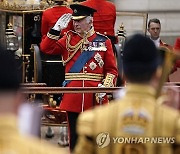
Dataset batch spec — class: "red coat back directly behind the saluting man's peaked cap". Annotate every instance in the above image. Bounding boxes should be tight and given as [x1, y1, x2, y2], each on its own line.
[81, 0, 116, 36]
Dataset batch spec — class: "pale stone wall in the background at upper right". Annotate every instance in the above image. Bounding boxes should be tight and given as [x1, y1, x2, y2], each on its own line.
[111, 0, 180, 45]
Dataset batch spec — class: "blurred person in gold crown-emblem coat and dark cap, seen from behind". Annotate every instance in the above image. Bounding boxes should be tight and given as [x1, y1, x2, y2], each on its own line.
[75, 34, 180, 154]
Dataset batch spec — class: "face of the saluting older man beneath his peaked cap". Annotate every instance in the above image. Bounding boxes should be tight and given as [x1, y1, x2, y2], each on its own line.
[73, 18, 91, 35]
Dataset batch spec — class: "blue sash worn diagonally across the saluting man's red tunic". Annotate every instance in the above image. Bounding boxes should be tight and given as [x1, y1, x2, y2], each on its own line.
[62, 35, 106, 87]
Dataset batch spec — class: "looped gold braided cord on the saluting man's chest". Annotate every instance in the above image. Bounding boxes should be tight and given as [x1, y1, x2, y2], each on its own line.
[63, 34, 84, 65]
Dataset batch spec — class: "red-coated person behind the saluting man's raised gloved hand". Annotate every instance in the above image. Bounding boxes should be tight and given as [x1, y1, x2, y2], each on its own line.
[41, 0, 73, 39]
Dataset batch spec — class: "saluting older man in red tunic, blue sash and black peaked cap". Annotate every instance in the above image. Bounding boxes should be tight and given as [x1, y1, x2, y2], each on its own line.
[41, 4, 118, 151]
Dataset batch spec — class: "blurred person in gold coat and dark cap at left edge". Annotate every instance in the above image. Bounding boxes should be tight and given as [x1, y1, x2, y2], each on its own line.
[0, 47, 66, 154]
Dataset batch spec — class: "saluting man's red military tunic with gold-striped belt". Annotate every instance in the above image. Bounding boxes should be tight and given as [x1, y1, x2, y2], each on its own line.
[41, 28, 118, 113]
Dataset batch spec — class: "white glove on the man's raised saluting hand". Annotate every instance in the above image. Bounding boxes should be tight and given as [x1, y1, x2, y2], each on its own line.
[52, 13, 72, 31]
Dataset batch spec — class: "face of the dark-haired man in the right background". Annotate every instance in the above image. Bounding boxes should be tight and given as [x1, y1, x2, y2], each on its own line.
[148, 22, 161, 40]
